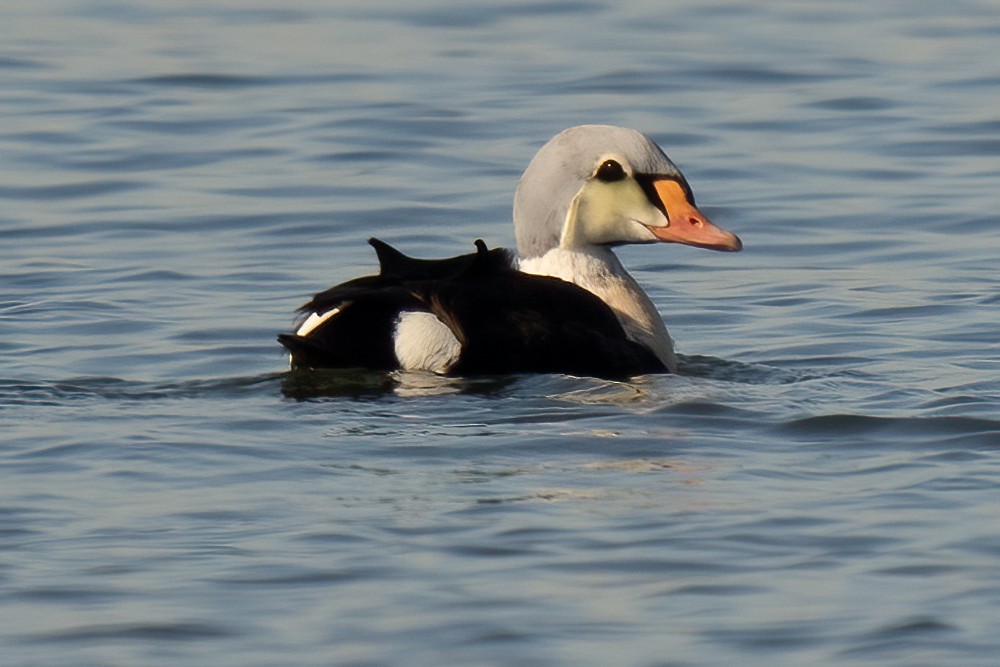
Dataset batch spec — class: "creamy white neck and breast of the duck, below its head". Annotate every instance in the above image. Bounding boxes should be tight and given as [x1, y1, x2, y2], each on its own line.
[520, 246, 677, 372]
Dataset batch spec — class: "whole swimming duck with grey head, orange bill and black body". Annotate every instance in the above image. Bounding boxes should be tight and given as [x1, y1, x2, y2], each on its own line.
[278, 125, 743, 379]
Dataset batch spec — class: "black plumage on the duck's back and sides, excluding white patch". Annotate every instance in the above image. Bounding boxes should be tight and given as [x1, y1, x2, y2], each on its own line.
[278, 239, 667, 378]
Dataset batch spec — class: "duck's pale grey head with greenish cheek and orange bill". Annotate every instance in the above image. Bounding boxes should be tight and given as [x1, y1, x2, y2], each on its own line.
[514, 125, 743, 259]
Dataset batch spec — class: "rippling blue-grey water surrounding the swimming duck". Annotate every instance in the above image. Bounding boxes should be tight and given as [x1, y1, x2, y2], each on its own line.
[0, 0, 1000, 667]
